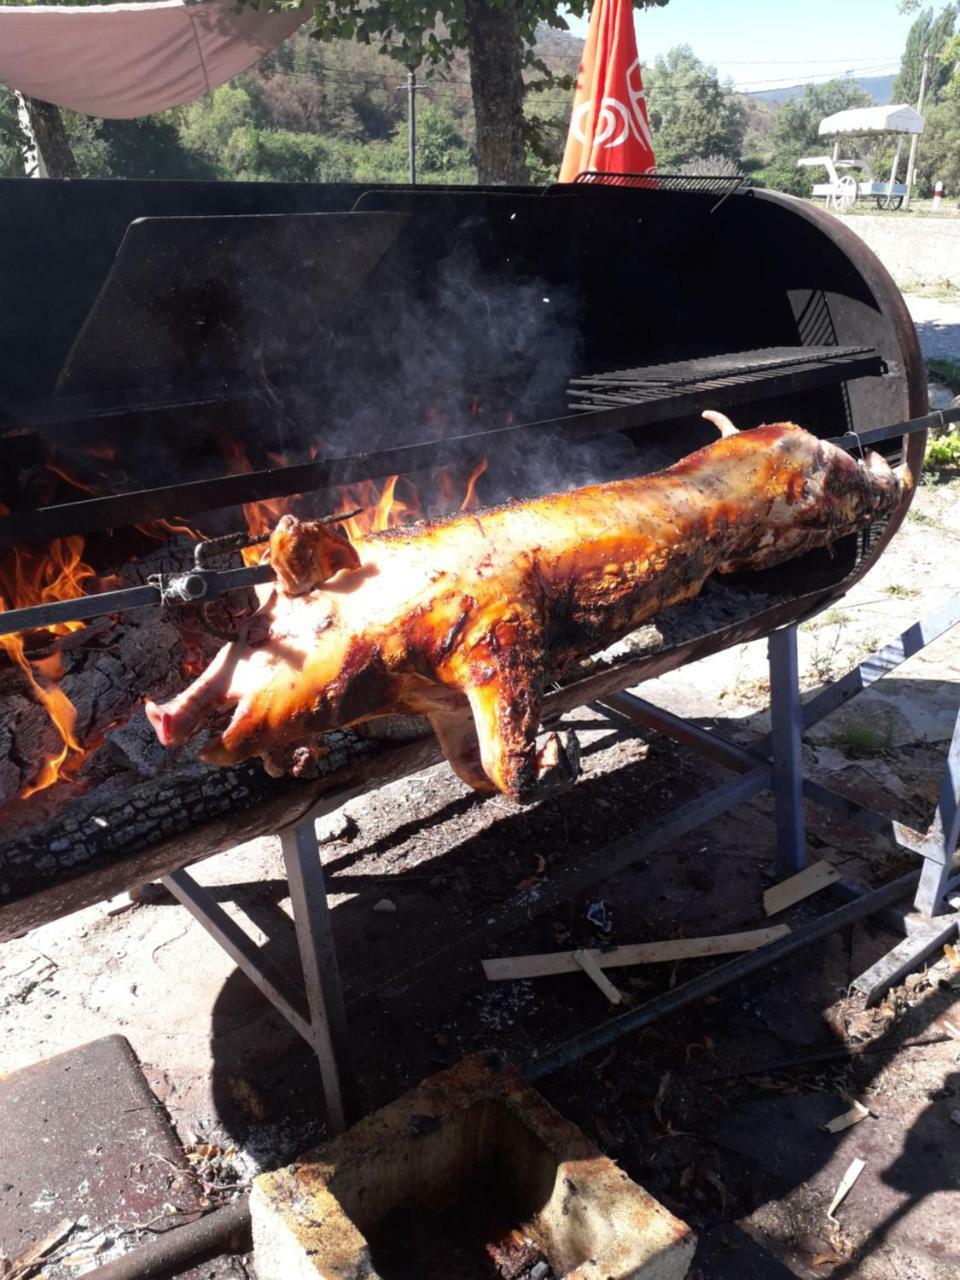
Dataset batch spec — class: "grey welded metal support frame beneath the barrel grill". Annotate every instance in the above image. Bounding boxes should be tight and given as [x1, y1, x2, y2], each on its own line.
[148, 595, 960, 1133]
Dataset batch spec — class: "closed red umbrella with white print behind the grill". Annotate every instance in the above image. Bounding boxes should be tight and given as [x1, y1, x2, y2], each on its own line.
[559, 0, 657, 182]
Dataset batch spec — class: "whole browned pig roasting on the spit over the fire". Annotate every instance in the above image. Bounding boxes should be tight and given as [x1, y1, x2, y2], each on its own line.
[147, 413, 911, 801]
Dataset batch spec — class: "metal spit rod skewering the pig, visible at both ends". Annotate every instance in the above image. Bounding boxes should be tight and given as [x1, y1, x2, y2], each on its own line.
[0, 406, 960, 635]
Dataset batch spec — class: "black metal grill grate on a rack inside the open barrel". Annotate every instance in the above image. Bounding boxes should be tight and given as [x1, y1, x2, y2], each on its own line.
[568, 347, 883, 408]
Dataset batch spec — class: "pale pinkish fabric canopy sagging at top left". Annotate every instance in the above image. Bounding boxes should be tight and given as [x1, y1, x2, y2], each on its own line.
[0, 0, 312, 119]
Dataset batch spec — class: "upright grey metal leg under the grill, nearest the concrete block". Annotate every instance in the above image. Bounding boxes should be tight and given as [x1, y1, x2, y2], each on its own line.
[280, 818, 360, 1134]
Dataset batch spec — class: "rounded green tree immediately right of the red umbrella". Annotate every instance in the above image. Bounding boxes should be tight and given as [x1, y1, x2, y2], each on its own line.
[646, 45, 746, 173]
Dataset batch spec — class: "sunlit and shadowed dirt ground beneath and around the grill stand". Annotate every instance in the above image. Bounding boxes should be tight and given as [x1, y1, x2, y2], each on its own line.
[0, 465, 960, 1280]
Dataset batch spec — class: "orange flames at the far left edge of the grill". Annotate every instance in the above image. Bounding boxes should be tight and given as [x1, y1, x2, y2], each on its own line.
[0, 508, 96, 800]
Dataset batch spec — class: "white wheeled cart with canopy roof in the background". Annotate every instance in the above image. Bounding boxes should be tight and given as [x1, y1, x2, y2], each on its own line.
[797, 102, 923, 212]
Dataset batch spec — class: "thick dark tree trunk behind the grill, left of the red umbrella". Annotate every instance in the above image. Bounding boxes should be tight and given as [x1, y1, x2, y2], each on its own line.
[465, 0, 526, 184]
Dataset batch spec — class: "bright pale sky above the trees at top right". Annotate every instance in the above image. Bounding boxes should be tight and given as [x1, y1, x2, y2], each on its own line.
[570, 0, 921, 91]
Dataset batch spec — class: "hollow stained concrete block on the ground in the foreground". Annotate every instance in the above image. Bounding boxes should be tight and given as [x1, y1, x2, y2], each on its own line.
[251, 1053, 696, 1280]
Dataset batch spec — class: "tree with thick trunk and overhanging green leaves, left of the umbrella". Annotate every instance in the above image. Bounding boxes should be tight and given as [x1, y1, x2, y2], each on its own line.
[243, 0, 667, 183]
